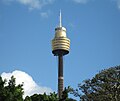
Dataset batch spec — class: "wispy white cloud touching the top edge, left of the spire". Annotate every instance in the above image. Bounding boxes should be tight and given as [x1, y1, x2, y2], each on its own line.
[3, 0, 54, 9]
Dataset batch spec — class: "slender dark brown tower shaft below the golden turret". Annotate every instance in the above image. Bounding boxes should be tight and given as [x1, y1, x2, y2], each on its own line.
[58, 55, 64, 98]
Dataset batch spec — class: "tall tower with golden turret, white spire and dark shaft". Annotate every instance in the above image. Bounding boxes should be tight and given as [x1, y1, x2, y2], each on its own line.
[52, 11, 70, 98]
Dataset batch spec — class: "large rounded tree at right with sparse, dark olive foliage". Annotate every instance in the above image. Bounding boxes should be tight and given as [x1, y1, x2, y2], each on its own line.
[72, 66, 120, 101]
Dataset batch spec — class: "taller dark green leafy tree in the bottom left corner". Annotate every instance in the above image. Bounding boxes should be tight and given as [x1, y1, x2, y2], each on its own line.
[0, 76, 24, 101]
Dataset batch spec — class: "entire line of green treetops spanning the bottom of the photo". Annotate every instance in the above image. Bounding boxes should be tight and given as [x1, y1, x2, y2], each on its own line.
[0, 66, 120, 101]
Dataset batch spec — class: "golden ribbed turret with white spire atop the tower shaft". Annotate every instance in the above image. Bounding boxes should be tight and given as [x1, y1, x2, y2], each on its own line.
[52, 12, 70, 56]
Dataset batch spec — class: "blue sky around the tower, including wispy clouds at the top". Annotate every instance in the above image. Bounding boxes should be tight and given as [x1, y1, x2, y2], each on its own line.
[0, 0, 120, 98]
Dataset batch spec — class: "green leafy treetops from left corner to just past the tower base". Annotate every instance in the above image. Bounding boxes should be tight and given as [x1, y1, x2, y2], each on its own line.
[0, 76, 76, 101]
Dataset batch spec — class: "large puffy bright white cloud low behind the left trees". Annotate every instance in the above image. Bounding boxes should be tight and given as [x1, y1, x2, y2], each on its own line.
[1, 70, 53, 97]
